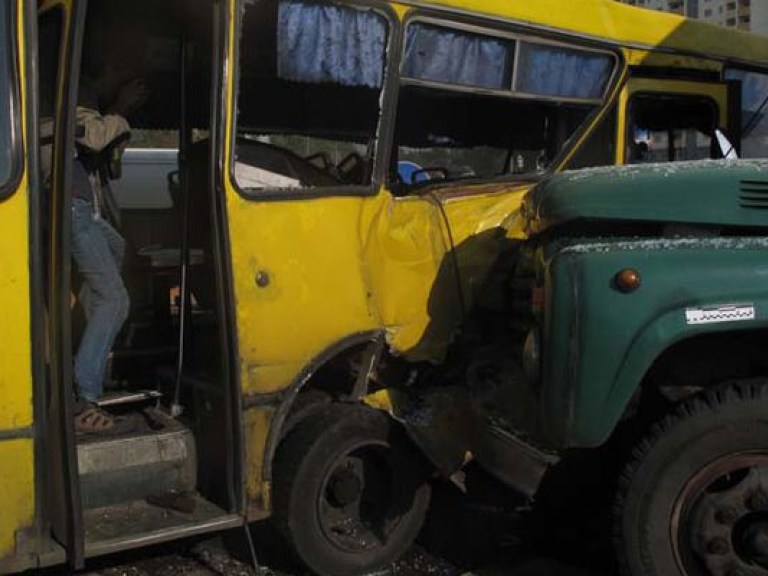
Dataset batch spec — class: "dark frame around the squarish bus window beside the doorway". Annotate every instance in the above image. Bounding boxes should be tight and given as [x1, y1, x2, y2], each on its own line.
[226, 0, 402, 202]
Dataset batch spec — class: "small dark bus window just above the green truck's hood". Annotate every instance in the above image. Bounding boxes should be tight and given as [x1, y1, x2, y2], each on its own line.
[626, 93, 720, 164]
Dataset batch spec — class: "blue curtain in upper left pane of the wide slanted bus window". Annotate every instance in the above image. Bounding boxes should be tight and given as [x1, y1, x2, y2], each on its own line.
[403, 24, 513, 89]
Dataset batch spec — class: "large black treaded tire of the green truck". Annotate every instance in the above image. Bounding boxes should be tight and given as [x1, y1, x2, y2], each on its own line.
[614, 381, 768, 576]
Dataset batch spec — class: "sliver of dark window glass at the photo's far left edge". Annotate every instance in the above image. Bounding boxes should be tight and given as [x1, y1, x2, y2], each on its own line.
[0, 2, 14, 188]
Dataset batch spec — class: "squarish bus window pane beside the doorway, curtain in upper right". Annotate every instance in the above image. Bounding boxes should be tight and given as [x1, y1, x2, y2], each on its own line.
[234, 0, 389, 193]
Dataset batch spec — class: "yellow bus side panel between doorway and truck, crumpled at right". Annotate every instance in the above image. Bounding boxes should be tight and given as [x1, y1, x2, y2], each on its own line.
[227, 178, 527, 518]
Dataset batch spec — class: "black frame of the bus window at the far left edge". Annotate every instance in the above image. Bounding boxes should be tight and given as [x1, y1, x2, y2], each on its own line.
[0, 2, 23, 202]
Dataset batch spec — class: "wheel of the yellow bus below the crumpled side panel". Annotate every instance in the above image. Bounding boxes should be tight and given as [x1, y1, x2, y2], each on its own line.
[273, 404, 431, 576]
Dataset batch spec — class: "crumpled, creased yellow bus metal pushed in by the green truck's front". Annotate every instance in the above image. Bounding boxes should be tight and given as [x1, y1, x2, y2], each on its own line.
[363, 184, 528, 362]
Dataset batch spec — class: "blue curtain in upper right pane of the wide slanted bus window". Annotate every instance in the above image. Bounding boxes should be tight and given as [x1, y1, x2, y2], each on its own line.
[515, 42, 614, 99]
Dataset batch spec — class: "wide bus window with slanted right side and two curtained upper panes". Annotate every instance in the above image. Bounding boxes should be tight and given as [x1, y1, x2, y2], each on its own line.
[390, 21, 615, 191]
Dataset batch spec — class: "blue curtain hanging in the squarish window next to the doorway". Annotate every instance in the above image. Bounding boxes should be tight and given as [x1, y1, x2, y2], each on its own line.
[277, 1, 387, 88]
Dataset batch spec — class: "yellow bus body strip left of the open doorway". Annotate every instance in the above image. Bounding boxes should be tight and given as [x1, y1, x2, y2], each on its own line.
[0, 0, 35, 564]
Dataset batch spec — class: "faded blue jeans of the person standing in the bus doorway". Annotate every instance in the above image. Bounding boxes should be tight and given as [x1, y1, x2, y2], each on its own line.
[72, 198, 130, 402]
